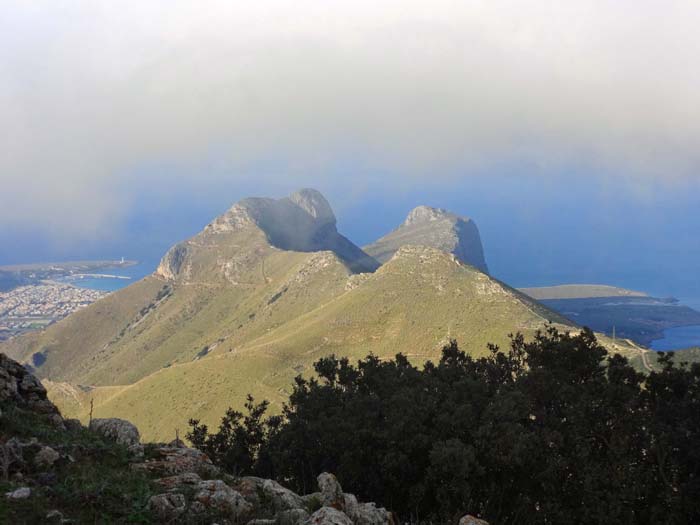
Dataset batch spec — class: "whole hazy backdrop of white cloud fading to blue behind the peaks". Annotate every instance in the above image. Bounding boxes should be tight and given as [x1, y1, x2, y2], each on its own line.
[0, 0, 700, 297]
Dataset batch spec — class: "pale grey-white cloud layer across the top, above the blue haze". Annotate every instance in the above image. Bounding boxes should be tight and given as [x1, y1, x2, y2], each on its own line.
[0, 0, 700, 238]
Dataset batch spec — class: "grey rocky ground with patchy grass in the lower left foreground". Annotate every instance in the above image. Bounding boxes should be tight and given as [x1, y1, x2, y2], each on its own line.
[0, 354, 396, 525]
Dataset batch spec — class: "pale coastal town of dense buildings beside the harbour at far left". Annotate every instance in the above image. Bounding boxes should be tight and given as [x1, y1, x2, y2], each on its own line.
[0, 281, 107, 341]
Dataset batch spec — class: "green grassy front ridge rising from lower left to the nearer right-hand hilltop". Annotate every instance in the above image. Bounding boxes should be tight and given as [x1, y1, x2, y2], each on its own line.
[50, 247, 576, 439]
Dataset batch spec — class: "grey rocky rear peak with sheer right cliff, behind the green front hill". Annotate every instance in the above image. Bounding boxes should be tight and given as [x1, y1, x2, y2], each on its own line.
[364, 206, 488, 273]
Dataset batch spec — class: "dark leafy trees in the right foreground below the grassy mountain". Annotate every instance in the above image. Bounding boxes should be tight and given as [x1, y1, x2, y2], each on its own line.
[188, 328, 700, 524]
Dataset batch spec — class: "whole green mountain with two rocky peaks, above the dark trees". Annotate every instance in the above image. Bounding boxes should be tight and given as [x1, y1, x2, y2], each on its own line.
[0, 189, 574, 440]
